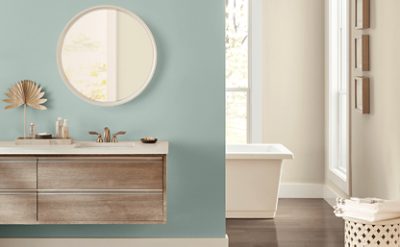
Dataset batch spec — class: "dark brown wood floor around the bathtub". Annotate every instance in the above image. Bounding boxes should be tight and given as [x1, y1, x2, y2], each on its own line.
[226, 199, 344, 247]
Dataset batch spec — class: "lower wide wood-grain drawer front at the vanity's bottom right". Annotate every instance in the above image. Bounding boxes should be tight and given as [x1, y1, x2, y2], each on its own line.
[38, 193, 164, 224]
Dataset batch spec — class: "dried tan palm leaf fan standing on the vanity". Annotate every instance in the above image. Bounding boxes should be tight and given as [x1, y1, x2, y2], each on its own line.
[3, 80, 47, 138]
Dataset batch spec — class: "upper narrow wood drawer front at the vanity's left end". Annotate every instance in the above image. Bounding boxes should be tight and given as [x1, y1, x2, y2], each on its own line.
[0, 158, 36, 189]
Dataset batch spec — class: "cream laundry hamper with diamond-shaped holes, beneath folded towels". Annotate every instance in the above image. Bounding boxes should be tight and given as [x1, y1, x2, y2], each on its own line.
[343, 217, 400, 247]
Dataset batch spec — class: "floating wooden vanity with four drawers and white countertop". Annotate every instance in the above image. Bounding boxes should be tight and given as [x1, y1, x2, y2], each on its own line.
[0, 143, 168, 224]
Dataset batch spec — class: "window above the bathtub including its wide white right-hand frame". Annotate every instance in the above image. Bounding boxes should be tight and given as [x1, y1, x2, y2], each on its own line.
[225, 0, 264, 145]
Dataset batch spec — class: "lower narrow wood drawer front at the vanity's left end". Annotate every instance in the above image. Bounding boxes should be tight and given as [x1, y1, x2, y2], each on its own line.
[0, 193, 36, 224]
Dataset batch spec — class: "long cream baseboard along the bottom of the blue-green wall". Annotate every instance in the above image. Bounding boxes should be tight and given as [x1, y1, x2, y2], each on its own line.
[0, 236, 229, 247]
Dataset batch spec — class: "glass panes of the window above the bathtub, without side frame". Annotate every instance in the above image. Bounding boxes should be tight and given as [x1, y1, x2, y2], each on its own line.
[225, 0, 250, 144]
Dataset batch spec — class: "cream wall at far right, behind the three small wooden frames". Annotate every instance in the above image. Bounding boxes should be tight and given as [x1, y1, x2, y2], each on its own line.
[351, 0, 400, 199]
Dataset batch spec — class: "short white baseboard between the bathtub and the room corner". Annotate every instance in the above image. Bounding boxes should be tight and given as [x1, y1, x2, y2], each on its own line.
[278, 183, 324, 198]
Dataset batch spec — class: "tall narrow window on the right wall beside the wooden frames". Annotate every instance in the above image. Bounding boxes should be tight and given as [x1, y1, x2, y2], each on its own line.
[329, 0, 349, 181]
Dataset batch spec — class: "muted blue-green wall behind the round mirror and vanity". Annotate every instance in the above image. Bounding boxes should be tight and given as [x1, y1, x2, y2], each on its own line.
[0, 0, 225, 237]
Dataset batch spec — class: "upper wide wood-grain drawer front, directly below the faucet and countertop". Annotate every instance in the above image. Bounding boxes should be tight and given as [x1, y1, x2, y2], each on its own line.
[38, 157, 164, 190]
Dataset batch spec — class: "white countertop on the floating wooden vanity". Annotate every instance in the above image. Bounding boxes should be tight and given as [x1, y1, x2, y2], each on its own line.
[0, 141, 168, 156]
